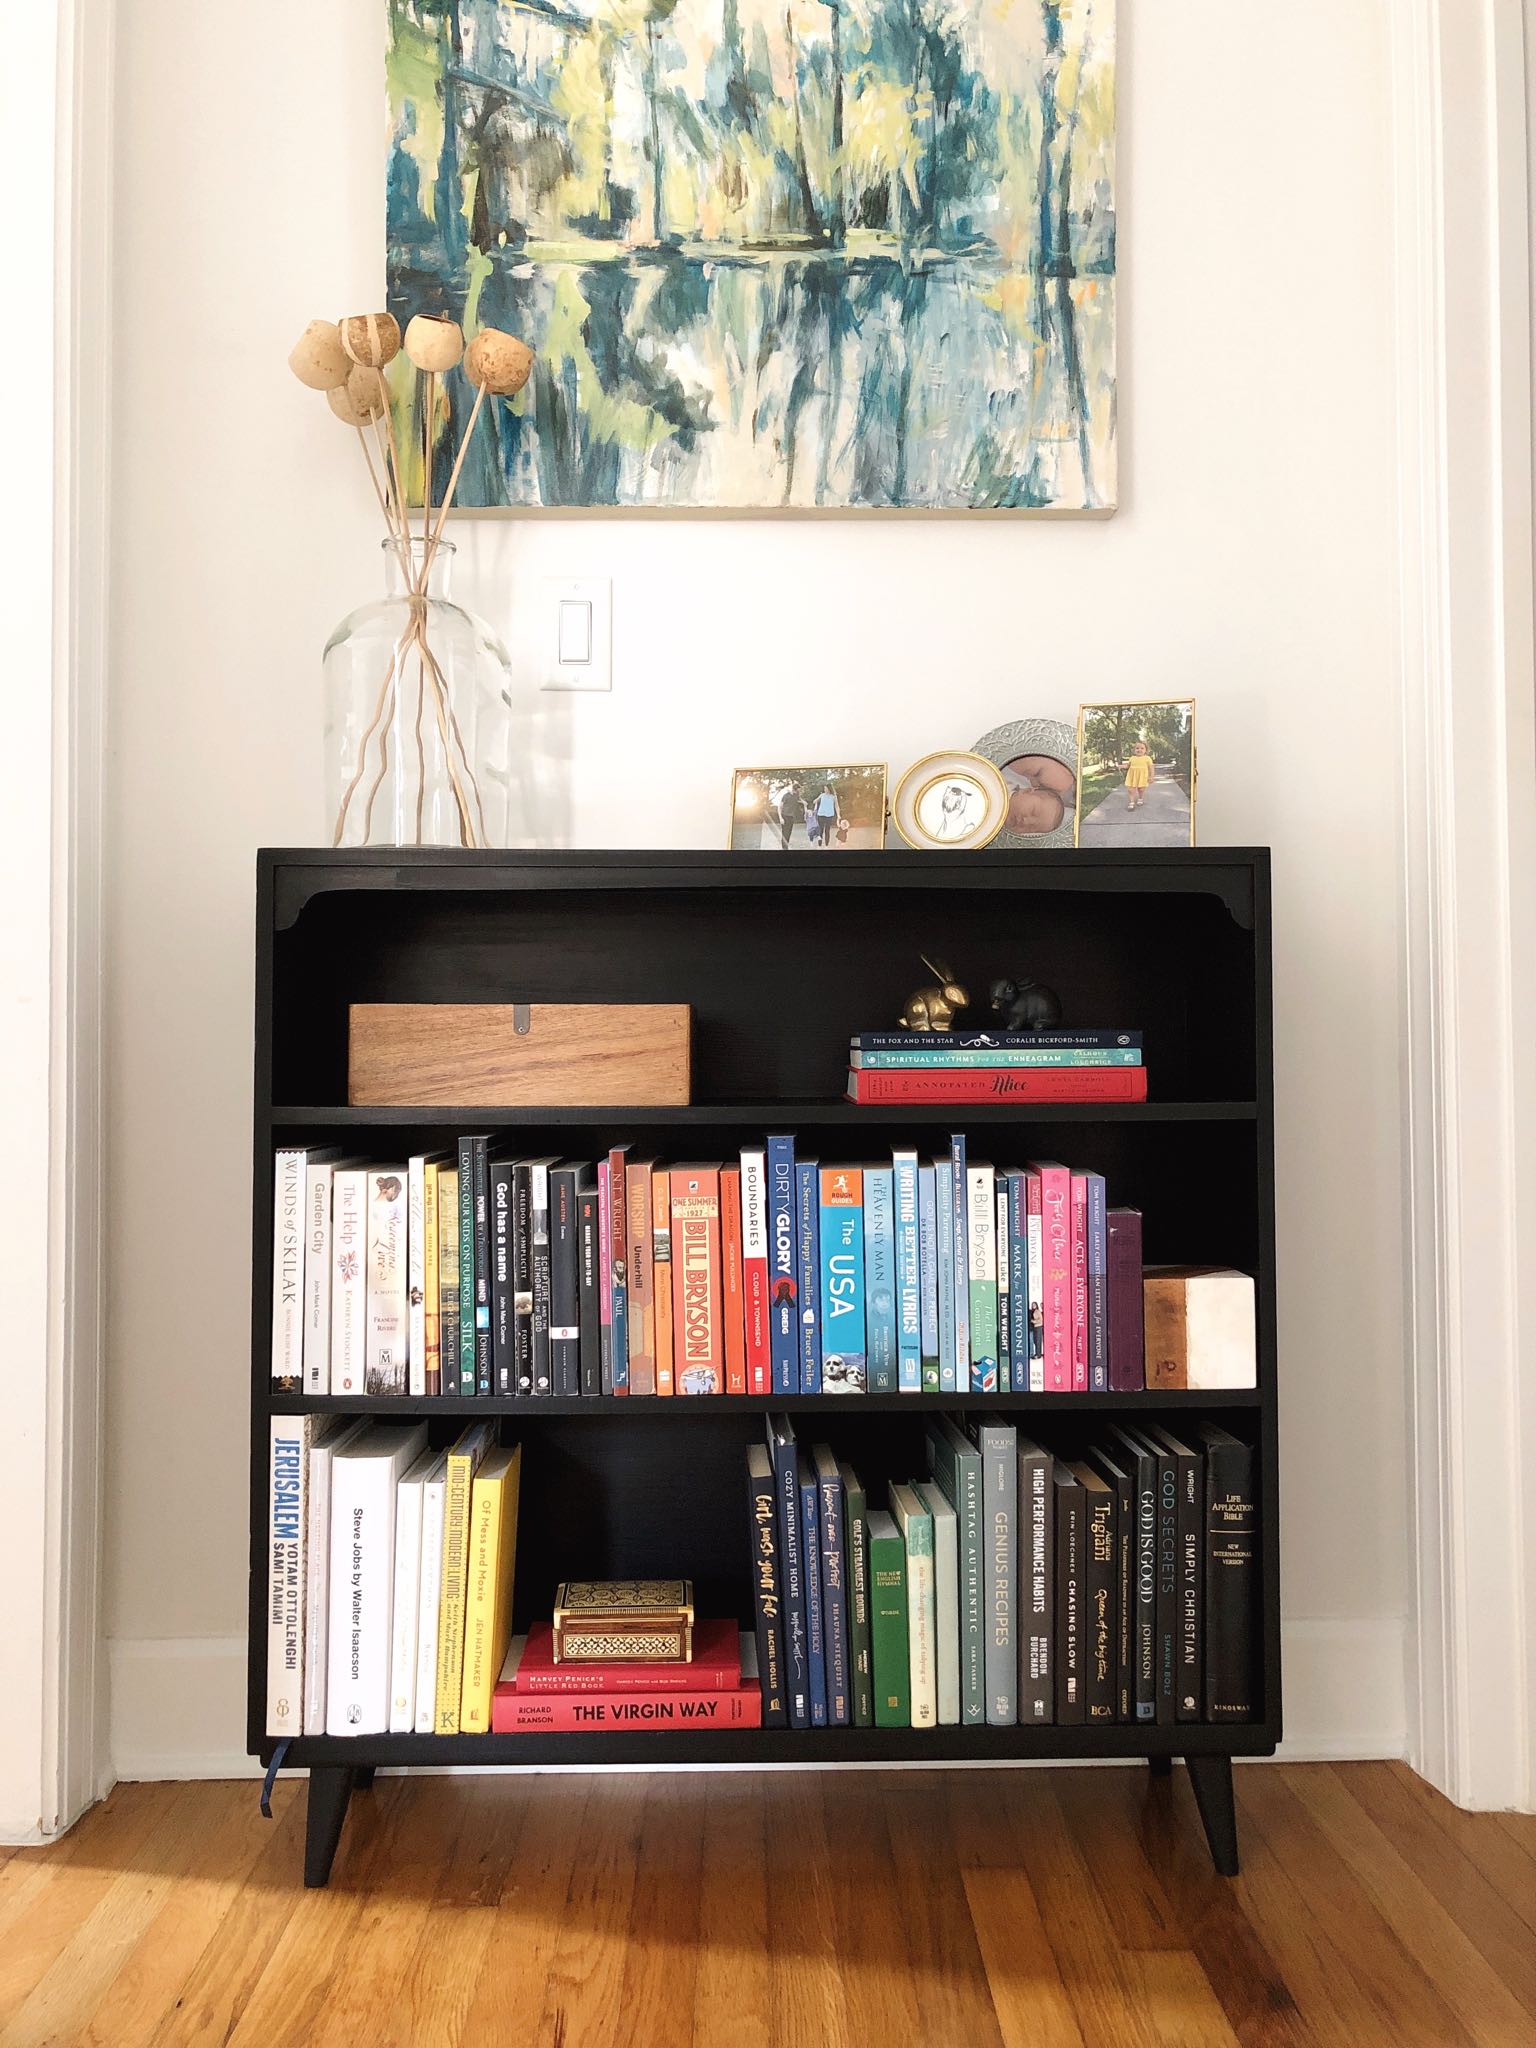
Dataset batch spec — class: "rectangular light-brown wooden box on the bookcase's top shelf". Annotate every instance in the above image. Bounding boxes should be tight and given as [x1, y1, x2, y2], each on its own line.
[346, 1004, 692, 1108]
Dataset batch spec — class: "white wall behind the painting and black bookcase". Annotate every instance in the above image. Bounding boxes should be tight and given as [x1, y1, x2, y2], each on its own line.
[106, 0, 1405, 1774]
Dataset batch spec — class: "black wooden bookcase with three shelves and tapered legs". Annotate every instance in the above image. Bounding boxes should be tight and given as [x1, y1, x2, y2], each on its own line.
[248, 848, 1280, 1884]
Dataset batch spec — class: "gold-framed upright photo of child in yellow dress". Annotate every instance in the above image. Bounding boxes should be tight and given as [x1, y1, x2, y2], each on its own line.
[1071, 696, 1200, 850]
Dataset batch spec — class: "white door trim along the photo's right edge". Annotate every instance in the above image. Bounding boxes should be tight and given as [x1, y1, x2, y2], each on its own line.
[1389, 0, 1536, 1806]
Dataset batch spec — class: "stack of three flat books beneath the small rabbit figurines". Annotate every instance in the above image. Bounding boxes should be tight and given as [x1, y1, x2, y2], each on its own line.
[848, 1030, 1147, 1102]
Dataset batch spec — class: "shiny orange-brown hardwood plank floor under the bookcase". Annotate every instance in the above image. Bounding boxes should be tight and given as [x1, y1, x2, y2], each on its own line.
[0, 1763, 1536, 2048]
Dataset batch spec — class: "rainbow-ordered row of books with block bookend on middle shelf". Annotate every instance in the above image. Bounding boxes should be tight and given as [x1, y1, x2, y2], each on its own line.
[272, 1133, 1255, 1399]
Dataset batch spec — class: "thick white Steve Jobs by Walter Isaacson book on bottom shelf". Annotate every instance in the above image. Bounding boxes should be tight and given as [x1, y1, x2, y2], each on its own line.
[326, 1421, 426, 1735]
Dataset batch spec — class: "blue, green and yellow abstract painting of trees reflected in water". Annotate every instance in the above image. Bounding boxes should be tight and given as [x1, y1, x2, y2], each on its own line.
[387, 0, 1116, 512]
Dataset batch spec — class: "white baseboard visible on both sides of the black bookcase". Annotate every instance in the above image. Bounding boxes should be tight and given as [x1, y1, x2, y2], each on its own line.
[111, 1616, 1407, 1780]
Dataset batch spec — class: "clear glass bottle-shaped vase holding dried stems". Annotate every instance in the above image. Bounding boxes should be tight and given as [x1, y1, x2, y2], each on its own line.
[324, 537, 512, 846]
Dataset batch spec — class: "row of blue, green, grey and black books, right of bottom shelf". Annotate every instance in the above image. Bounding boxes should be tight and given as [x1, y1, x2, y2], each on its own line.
[748, 1415, 1260, 1729]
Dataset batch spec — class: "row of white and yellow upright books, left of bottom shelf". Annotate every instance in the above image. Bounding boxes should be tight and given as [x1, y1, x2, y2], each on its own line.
[266, 1415, 522, 1739]
